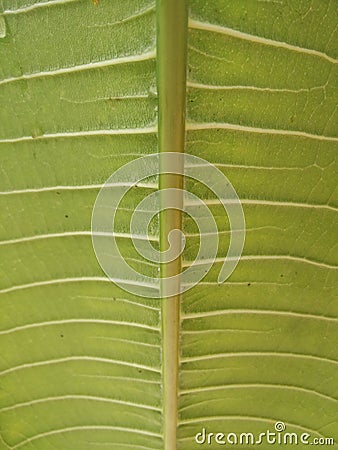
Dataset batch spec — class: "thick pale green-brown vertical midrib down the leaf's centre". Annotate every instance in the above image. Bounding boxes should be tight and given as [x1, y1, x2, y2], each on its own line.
[157, 0, 188, 450]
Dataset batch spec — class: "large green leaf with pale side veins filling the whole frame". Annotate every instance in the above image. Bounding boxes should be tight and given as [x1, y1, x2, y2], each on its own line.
[0, 0, 338, 450]
